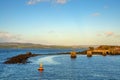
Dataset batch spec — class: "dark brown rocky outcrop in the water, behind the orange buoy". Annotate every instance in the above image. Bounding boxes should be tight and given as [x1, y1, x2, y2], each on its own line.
[4, 52, 38, 64]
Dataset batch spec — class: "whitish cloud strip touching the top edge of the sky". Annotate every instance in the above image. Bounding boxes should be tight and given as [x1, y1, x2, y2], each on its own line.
[27, 0, 68, 5]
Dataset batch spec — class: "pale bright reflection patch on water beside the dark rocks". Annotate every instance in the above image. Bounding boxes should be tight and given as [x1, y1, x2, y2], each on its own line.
[30, 56, 60, 65]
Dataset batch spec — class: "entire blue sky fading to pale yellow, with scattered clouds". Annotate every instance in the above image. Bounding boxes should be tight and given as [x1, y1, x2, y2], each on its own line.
[0, 0, 120, 45]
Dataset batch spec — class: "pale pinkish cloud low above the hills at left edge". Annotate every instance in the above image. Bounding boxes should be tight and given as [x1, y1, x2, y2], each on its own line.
[0, 32, 21, 42]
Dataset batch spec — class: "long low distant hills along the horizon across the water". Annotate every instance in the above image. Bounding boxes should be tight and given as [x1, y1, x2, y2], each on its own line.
[0, 42, 92, 48]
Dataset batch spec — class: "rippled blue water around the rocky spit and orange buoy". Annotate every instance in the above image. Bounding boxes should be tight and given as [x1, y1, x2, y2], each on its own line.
[0, 49, 120, 80]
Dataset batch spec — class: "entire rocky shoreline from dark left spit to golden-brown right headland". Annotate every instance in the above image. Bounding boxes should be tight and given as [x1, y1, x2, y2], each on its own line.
[4, 46, 120, 64]
